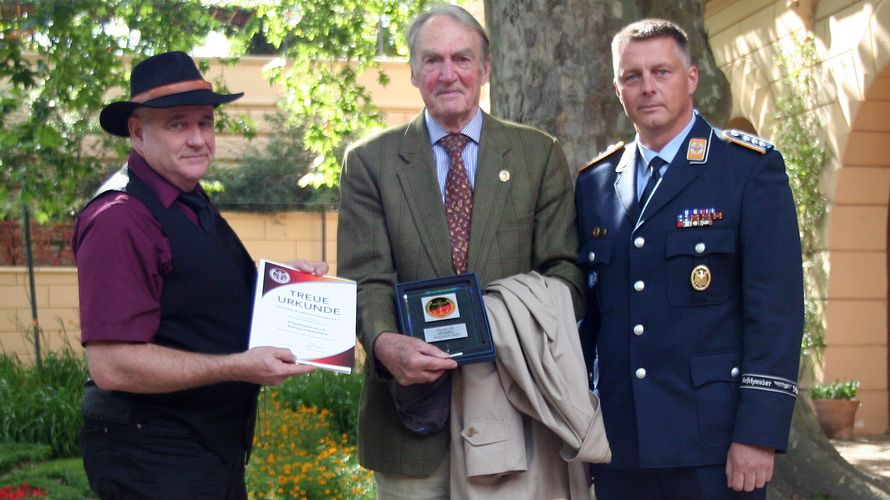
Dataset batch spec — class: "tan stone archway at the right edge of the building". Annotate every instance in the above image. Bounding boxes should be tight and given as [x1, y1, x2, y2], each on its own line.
[824, 65, 890, 433]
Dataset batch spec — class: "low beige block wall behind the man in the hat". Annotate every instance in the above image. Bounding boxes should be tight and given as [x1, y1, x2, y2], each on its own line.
[0, 212, 337, 361]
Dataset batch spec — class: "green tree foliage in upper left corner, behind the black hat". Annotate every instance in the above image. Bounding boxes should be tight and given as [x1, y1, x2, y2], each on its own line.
[0, 0, 229, 221]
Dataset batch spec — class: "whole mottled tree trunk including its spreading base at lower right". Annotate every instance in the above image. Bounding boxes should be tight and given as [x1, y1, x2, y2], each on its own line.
[485, 0, 887, 499]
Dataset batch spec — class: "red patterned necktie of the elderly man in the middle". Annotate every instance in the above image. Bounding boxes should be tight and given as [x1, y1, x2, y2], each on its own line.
[439, 134, 473, 274]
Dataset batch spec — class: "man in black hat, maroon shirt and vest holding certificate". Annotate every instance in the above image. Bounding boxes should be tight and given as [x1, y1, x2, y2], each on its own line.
[73, 52, 327, 499]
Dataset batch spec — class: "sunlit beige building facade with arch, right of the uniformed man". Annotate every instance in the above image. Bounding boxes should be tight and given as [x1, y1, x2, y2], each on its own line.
[705, 0, 890, 434]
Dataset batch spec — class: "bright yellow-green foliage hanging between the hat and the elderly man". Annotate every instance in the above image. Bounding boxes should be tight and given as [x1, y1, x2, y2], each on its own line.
[239, 0, 426, 187]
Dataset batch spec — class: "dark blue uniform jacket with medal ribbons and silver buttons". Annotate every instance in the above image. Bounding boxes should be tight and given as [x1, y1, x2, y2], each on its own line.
[576, 117, 803, 468]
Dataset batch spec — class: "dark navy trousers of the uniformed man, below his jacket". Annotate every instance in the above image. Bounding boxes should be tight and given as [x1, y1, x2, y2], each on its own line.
[592, 465, 766, 500]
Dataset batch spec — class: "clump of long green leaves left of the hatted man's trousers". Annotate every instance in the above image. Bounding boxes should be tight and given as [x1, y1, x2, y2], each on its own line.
[0, 349, 87, 457]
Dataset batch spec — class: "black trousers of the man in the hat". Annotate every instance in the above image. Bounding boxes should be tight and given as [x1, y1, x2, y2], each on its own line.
[81, 417, 247, 500]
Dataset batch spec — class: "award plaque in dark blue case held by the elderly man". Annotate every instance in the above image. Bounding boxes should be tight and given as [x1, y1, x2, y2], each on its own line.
[396, 273, 495, 364]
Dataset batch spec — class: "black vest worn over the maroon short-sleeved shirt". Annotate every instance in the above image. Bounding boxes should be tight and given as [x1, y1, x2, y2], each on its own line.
[85, 168, 259, 461]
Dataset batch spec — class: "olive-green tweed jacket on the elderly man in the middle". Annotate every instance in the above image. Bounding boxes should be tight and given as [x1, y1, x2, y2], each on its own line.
[337, 114, 583, 476]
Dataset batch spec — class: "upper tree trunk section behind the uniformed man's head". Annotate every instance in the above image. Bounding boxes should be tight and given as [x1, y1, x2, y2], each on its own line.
[485, 0, 732, 171]
